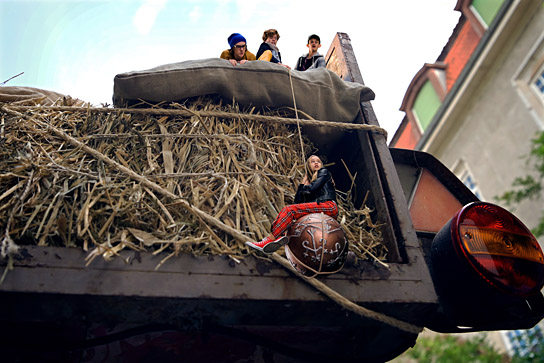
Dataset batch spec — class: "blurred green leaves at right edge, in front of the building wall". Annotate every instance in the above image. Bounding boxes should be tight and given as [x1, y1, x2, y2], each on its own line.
[497, 131, 544, 237]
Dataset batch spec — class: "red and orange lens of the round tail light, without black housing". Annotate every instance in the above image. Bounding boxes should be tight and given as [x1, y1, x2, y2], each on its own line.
[451, 202, 544, 297]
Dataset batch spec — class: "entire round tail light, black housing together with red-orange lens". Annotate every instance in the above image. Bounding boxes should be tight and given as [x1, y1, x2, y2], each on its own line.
[428, 202, 544, 332]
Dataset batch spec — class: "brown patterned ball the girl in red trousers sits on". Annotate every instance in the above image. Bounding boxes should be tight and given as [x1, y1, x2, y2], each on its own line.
[285, 213, 349, 276]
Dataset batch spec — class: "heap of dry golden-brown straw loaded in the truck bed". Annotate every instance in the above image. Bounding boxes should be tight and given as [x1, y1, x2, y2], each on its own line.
[0, 97, 386, 267]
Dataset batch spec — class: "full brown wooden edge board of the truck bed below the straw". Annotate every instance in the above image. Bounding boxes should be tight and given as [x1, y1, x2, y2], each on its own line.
[0, 246, 436, 303]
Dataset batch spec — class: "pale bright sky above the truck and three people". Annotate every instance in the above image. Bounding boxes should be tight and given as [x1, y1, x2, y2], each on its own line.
[0, 0, 460, 140]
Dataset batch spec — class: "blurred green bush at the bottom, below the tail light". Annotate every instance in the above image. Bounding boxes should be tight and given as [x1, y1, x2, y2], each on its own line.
[405, 335, 510, 363]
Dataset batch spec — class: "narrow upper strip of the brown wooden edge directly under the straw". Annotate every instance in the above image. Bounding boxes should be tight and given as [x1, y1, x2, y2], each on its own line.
[9, 246, 434, 282]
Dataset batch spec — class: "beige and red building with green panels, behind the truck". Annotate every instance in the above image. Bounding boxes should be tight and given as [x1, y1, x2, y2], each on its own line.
[390, 0, 544, 354]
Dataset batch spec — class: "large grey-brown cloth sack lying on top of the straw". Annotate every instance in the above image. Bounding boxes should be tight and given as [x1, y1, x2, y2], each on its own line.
[113, 58, 374, 122]
